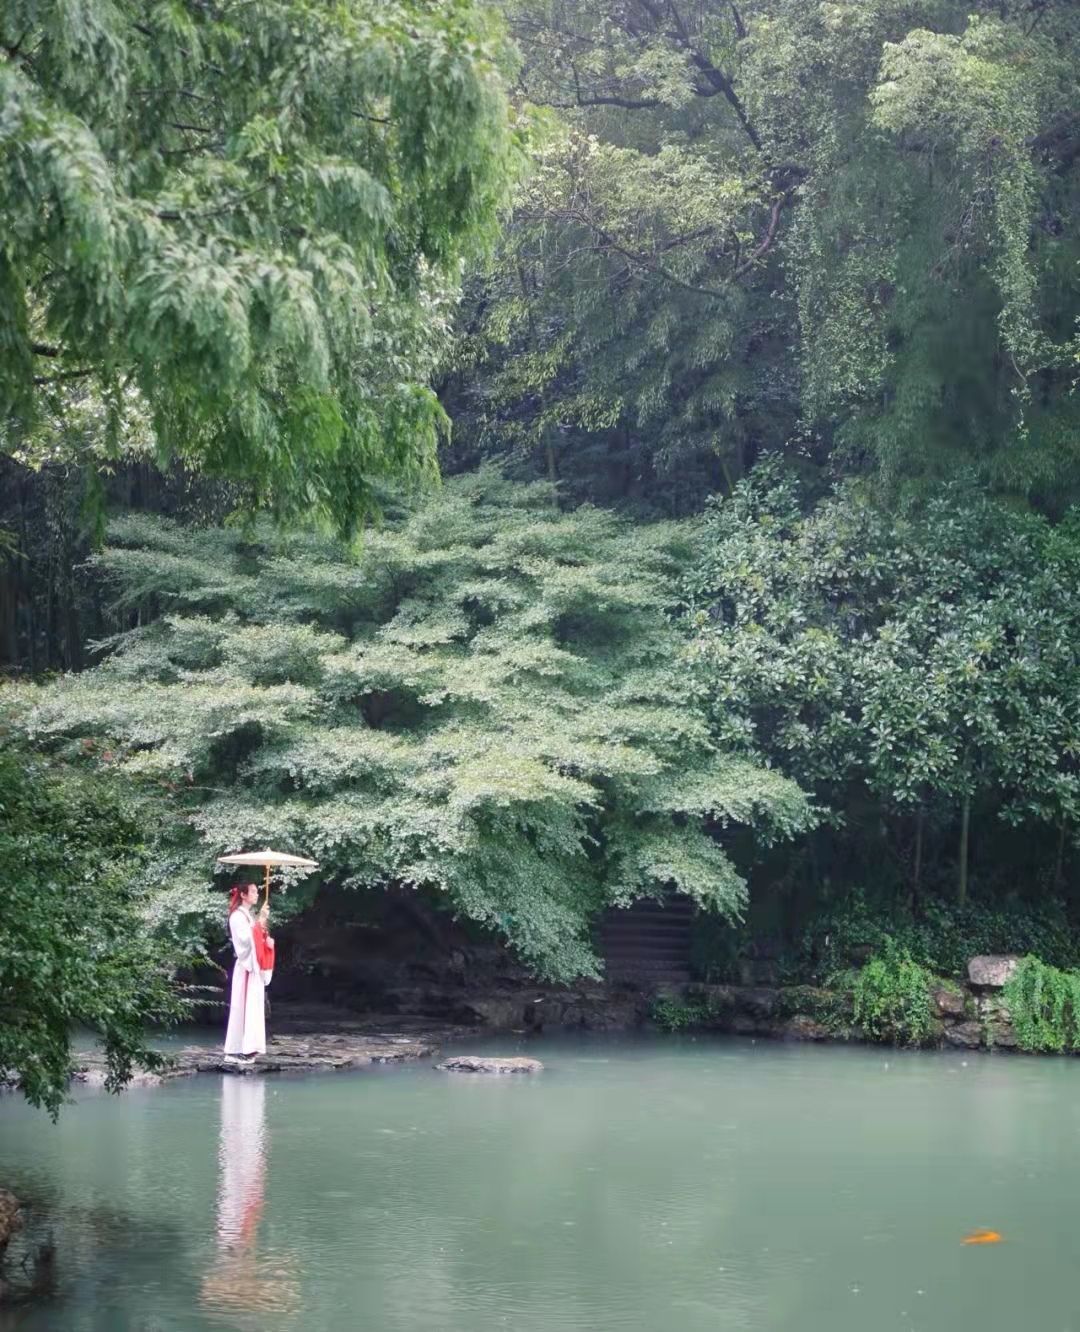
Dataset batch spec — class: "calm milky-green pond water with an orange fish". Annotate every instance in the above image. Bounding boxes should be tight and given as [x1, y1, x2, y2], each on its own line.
[0, 1040, 1080, 1332]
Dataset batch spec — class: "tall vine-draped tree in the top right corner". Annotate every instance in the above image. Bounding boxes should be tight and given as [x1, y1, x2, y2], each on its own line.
[788, 0, 1080, 490]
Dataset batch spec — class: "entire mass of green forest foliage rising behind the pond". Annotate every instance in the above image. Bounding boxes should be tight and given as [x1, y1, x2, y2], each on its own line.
[0, 0, 1080, 1106]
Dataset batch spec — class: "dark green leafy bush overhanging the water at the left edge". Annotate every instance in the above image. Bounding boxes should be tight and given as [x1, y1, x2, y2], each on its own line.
[0, 733, 205, 1116]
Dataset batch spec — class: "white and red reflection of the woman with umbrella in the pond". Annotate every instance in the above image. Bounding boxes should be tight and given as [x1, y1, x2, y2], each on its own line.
[201, 1076, 300, 1327]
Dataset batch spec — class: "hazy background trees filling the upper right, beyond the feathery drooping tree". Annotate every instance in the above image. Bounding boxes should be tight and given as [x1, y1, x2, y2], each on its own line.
[447, 0, 1080, 509]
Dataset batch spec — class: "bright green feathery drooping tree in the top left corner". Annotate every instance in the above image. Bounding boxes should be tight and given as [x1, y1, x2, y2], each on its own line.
[0, 0, 515, 529]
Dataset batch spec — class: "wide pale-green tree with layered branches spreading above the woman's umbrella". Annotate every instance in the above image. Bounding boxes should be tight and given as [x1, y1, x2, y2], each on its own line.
[15, 469, 811, 976]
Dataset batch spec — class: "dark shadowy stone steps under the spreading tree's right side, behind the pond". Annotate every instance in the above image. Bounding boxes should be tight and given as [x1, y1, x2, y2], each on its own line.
[599, 894, 695, 987]
